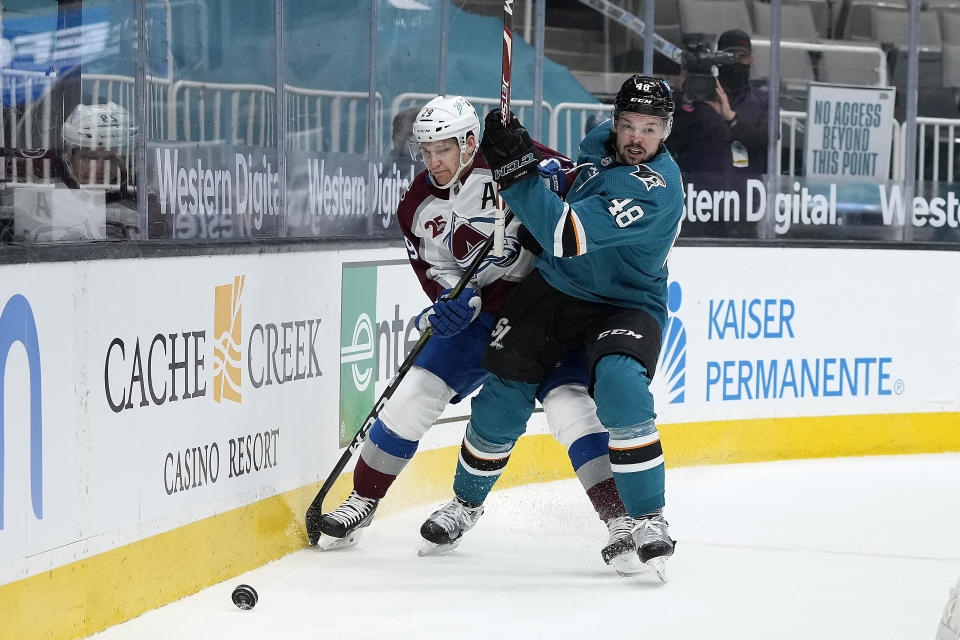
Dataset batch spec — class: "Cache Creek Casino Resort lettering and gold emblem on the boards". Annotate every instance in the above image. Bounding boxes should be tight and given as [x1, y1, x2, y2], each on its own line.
[103, 275, 323, 495]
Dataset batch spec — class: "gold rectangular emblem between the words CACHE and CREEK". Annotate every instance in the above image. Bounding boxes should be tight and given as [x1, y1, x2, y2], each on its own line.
[213, 276, 246, 404]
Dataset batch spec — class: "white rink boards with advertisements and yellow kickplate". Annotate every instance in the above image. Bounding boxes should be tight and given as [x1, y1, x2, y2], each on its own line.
[0, 247, 960, 637]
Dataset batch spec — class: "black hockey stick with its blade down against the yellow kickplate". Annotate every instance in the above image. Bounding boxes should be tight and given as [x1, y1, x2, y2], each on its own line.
[305, 209, 513, 545]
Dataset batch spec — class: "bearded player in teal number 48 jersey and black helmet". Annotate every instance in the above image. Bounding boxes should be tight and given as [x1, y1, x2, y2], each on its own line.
[421, 75, 683, 579]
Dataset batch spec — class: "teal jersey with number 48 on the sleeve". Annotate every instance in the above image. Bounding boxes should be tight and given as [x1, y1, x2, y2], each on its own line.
[501, 120, 683, 327]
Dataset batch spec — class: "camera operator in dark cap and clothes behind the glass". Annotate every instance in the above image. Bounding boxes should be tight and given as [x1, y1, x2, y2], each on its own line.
[669, 29, 769, 179]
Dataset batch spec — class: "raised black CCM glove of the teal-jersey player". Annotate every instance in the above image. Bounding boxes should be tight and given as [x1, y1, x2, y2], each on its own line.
[480, 109, 540, 189]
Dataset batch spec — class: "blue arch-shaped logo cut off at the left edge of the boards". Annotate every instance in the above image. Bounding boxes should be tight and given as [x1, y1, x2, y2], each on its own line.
[0, 294, 43, 530]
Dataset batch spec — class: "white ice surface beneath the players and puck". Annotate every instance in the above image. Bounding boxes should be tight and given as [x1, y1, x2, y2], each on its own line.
[93, 453, 960, 640]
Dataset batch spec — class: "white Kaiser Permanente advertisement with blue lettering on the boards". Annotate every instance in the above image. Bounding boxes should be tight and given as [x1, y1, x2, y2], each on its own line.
[651, 247, 960, 423]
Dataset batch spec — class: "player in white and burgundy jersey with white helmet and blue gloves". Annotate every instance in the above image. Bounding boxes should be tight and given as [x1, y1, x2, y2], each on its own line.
[318, 96, 642, 574]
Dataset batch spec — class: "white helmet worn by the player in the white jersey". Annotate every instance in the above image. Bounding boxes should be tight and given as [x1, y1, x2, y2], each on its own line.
[411, 96, 480, 189]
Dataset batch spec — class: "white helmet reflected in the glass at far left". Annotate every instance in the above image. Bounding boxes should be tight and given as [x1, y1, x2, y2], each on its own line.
[61, 102, 139, 188]
